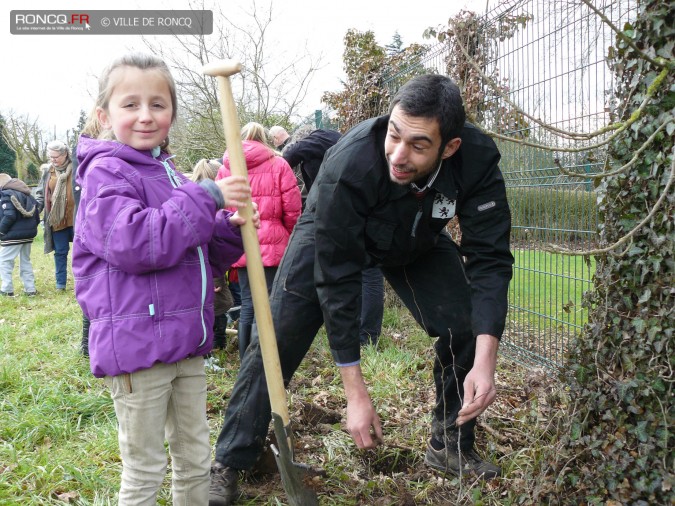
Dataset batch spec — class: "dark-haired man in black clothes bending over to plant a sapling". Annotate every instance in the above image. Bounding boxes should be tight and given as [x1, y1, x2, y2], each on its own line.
[209, 75, 513, 506]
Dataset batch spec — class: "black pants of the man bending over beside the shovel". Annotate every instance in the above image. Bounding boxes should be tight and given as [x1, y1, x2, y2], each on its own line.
[216, 227, 476, 469]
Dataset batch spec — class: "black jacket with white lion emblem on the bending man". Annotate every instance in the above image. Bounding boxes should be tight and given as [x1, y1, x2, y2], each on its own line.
[298, 116, 513, 364]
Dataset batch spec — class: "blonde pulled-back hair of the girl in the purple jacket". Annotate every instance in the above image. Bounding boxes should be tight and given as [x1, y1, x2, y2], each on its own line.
[82, 53, 178, 150]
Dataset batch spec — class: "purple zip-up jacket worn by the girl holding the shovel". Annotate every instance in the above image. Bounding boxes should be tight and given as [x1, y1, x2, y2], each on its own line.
[73, 136, 243, 377]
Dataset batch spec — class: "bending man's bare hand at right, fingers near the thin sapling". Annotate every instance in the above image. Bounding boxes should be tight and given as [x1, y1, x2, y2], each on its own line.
[457, 334, 499, 425]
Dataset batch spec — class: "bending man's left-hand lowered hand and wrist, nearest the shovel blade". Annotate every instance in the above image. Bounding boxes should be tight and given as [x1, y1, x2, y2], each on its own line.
[340, 365, 382, 448]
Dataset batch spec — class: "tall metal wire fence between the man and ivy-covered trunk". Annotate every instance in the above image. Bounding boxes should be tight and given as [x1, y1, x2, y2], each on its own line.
[382, 0, 636, 369]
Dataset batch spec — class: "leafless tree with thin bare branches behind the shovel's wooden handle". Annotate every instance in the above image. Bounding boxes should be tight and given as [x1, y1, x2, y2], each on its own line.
[144, 2, 320, 169]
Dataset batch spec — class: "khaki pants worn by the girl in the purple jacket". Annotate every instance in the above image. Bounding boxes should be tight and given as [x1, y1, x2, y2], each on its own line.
[105, 357, 211, 506]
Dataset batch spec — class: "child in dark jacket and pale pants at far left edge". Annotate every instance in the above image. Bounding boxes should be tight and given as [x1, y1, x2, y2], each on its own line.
[0, 173, 40, 297]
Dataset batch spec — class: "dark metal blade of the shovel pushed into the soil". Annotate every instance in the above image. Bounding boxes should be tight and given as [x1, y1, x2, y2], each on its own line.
[272, 413, 319, 506]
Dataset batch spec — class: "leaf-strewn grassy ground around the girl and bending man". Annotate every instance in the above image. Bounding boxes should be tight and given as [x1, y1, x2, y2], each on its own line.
[0, 232, 567, 505]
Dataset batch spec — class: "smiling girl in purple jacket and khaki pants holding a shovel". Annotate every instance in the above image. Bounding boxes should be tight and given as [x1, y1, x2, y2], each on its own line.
[73, 54, 258, 505]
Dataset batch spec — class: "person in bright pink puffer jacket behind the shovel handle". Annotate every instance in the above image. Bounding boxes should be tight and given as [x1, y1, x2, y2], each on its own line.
[216, 122, 302, 358]
